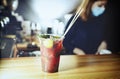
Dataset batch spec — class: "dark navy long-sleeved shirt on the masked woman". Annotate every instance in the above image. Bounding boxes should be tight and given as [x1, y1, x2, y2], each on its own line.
[63, 15, 105, 54]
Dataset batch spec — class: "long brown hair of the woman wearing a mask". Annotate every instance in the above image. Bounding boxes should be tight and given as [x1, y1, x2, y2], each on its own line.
[80, 0, 107, 21]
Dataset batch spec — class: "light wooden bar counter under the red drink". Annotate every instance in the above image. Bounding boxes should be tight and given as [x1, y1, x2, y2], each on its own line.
[0, 55, 120, 79]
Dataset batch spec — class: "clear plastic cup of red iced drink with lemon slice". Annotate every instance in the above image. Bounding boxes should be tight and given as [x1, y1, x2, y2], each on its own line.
[39, 34, 62, 73]
